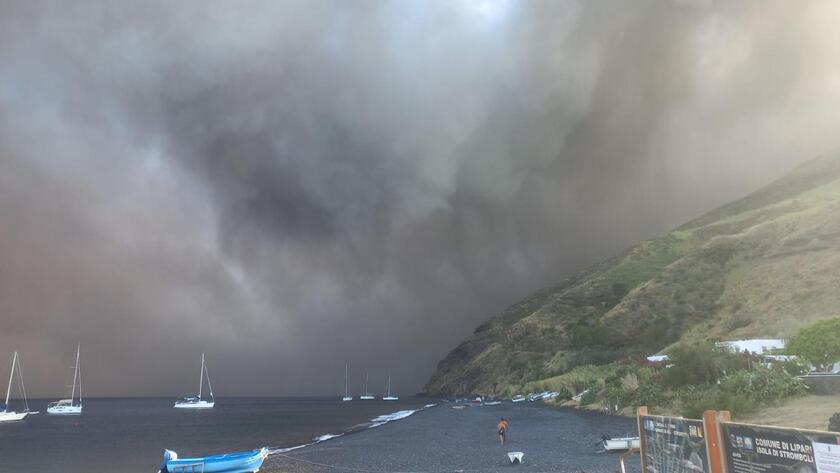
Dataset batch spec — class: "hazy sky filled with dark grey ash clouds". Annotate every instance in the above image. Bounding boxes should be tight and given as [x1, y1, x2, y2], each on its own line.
[0, 0, 840, 396]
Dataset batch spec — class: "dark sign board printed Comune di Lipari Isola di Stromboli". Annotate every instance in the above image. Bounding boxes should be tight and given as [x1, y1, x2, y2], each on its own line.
[721, 422, 840, 473]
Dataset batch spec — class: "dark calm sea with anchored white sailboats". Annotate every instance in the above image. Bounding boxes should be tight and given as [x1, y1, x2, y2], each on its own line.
[0, 398, 430, 473]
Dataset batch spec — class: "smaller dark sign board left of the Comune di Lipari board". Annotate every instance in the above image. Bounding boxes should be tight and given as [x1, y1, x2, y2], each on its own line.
[639, 415, 708, 473]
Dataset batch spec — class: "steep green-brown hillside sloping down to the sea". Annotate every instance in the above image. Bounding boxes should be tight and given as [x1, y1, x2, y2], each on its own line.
[425, 156, 840, 396]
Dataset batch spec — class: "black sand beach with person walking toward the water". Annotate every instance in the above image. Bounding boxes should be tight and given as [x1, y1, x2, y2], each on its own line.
[262, 402, 640, 473]
